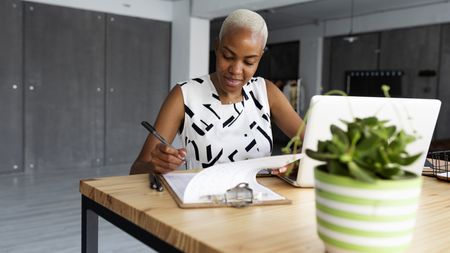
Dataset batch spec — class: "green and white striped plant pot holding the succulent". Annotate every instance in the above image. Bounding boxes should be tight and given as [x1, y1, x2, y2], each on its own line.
[314, 167, 422, 253]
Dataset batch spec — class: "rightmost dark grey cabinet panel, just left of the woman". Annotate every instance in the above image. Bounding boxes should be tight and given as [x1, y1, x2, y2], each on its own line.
[105, 15, 171, 164]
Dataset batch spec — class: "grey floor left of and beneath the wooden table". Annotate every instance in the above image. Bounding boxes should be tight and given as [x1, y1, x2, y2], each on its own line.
[0, 165, 155, 253]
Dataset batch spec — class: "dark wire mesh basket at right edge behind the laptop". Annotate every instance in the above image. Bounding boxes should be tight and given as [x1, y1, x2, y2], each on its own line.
[422, 150, 450, 182]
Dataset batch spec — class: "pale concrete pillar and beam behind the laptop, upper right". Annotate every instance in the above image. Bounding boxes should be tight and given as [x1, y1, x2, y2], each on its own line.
[269, 1, 450, 111]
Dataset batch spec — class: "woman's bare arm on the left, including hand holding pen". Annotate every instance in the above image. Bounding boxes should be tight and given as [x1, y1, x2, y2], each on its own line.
[130, 85, 186, 174]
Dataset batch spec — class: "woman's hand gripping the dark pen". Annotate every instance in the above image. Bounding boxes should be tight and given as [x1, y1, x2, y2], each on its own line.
[151, 143, 186, 174]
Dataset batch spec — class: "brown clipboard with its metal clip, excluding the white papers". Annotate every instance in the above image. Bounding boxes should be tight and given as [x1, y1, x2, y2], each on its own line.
[158, 170, 292, 209]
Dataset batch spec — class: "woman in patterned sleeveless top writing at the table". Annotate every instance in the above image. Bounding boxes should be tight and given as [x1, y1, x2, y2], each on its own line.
[130, 9, 303, 174]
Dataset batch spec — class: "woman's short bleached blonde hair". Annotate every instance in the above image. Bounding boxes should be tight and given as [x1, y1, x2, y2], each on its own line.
[219, 9, 268, 48]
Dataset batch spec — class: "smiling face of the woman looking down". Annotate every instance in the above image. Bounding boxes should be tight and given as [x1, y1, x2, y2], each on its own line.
[216, 28, 264, 93]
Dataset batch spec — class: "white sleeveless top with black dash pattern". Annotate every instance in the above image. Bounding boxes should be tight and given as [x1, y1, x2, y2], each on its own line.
[179, 75, 273, 169]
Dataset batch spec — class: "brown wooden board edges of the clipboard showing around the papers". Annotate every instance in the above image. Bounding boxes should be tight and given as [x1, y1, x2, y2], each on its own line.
[158, 170, 292, 208]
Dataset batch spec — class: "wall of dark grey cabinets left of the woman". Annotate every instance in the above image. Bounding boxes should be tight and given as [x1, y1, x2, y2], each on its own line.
[0, 0, 171, 173]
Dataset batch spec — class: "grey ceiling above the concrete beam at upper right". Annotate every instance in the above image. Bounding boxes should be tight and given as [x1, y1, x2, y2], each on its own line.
[211, 0, 449, 34]
